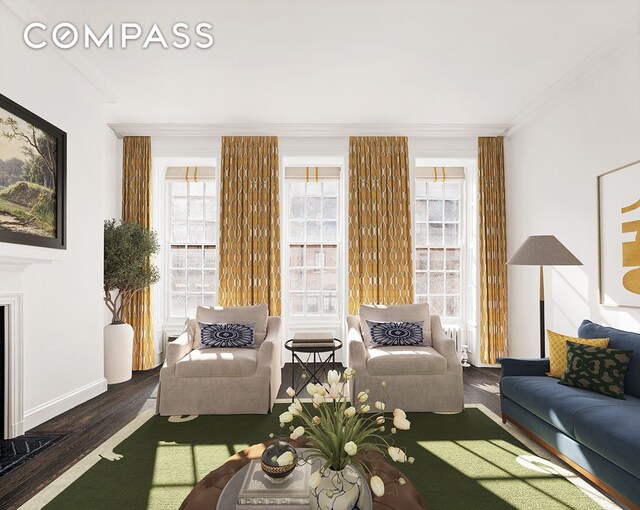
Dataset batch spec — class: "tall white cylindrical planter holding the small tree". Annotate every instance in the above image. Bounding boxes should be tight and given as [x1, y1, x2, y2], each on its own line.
[104, 324, 133, 384]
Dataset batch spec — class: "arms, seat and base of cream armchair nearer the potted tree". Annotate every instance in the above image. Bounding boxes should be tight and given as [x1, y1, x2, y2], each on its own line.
[158, 317, 282, 416]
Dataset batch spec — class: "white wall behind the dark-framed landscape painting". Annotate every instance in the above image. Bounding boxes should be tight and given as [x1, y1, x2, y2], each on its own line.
[0, 4, 106, 429]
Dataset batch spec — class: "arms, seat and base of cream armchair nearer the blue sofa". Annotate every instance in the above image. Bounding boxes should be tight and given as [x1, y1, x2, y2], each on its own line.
[347, 315, 464, 412]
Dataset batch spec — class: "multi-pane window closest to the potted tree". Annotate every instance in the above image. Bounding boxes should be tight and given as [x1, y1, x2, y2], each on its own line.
[167, 167, 218, 318]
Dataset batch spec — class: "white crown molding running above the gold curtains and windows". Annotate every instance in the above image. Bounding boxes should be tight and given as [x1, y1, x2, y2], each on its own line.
[109, 123, 510, 138]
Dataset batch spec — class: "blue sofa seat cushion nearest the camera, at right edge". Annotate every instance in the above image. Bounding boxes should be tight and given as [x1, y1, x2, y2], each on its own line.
[574, 396, 640, 478]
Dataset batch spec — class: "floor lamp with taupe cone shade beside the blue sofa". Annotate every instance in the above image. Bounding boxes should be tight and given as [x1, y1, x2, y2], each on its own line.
[507, 236, 582, 358]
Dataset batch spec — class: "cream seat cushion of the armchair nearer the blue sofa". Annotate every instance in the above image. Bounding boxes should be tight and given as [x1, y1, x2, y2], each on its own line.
[367, 346, 447, 375]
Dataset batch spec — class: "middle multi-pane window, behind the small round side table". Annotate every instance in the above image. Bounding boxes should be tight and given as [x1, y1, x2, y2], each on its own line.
[285, 168, 340, 319]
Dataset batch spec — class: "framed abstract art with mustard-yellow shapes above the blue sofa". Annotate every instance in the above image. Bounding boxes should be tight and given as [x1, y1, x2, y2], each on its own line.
[598, 161, 640, 308]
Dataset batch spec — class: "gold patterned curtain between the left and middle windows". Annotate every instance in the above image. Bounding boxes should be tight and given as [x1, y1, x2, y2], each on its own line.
[219, 136, 280, 315]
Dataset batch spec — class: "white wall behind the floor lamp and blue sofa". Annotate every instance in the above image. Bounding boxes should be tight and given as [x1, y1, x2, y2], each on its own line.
[506, 39, 640, 357]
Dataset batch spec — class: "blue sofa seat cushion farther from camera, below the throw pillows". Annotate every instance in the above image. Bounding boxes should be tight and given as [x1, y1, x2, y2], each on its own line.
[500, 376, 638, 437]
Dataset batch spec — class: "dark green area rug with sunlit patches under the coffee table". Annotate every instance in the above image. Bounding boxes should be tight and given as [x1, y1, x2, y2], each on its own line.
[39, 404, 602, 510]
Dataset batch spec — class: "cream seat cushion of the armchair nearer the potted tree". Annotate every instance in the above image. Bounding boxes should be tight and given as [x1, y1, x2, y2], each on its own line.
[176, 348, 258, 377]
